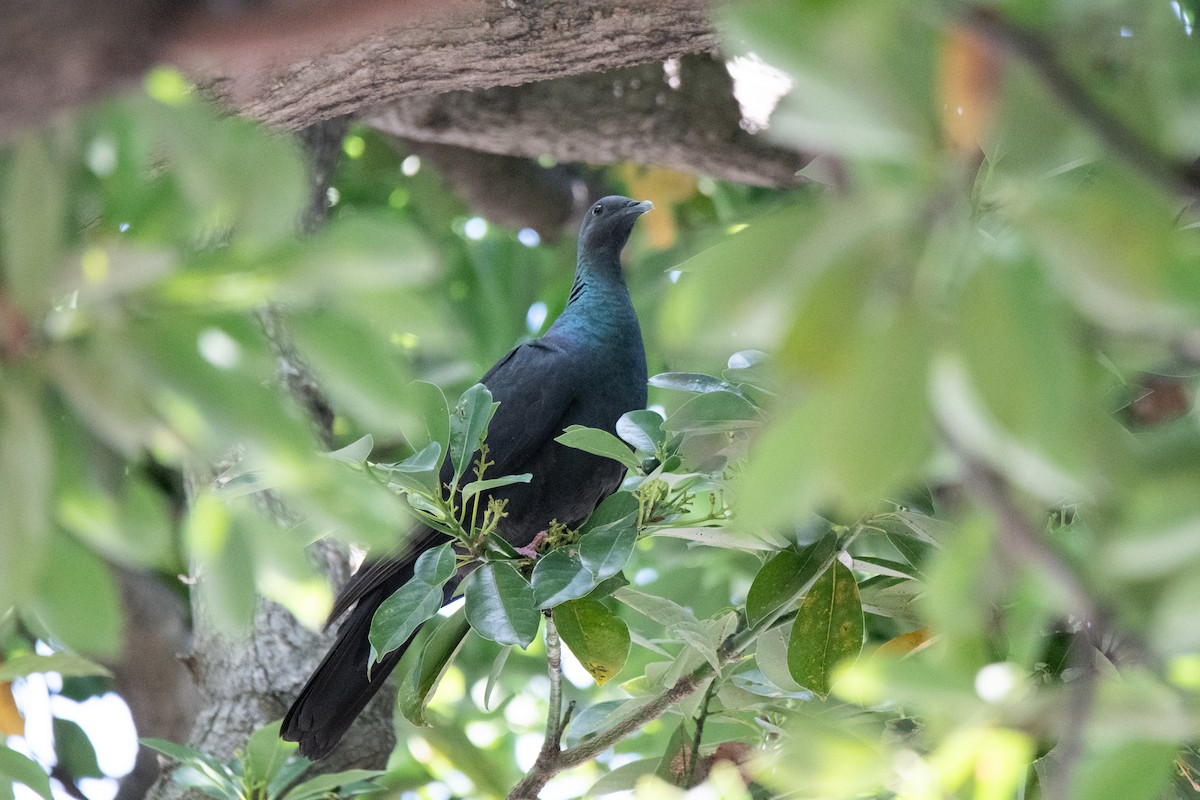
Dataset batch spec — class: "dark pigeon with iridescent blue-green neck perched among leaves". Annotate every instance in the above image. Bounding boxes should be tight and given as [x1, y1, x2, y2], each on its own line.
[282, 197, 653, 758]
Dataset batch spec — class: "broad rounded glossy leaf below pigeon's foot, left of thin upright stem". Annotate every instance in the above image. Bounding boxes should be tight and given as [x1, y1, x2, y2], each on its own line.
[463, 563, 541, 648]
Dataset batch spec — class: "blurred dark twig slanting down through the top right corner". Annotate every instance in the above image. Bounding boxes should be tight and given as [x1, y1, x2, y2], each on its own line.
[964, 6, 1200, 196]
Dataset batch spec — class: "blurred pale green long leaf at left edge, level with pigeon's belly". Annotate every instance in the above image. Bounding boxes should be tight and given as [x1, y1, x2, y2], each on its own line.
[0, 373, 54, 608]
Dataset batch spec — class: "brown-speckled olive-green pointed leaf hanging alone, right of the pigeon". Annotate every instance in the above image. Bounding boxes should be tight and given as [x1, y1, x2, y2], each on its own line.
[787, 561, 864, 698]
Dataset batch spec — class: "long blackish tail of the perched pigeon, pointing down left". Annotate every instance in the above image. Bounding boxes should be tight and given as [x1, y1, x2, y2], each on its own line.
[280, 582, 413, 759]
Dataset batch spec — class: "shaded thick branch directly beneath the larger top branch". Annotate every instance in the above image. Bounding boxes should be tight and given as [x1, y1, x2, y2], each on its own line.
[364, 55, 809, 186]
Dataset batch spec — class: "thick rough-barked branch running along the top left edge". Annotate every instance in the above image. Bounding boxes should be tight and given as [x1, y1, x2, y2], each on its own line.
[0, 0, 716, 137]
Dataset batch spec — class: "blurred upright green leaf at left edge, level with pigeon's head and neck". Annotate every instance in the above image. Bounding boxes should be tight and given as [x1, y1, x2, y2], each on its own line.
[0, 132, 68, 319]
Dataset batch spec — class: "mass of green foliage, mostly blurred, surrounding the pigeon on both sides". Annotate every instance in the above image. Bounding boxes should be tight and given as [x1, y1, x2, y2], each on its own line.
[0, 0, 1200, 800]
